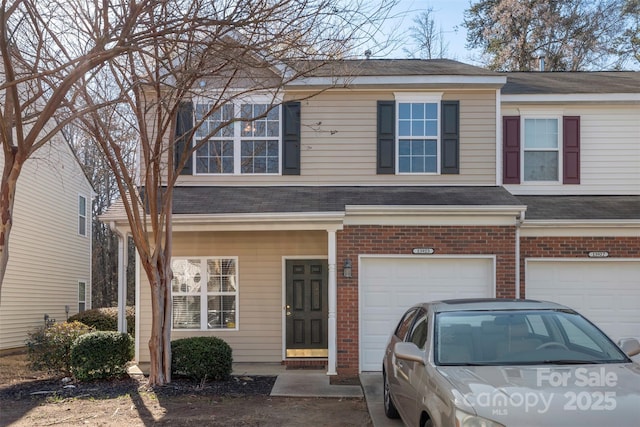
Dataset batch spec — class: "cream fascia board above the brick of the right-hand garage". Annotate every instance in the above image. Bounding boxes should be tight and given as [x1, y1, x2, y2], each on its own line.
[520, 219, 640, 237]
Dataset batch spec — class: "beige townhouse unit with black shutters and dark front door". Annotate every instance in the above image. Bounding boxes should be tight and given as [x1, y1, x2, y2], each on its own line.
[104, 60, 640, 376]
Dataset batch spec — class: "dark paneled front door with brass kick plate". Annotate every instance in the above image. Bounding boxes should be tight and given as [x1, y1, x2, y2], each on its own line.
[286, 260, 329, 357]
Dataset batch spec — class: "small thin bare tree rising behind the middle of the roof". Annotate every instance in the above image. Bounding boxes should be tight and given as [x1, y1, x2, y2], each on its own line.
[405, 7, 449, 59]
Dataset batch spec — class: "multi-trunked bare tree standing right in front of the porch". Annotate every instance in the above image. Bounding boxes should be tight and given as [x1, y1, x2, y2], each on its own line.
[70, 0, 394, 385]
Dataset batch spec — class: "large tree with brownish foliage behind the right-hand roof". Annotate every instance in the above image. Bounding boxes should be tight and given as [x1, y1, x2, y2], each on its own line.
[464, 0, 626, 71]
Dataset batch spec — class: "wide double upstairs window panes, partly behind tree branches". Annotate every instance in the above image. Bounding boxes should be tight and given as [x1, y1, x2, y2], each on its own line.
[195, 103, 281, 174]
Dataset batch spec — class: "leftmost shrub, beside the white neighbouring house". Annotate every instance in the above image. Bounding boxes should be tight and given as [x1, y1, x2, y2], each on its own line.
[27, 322, 93, 375]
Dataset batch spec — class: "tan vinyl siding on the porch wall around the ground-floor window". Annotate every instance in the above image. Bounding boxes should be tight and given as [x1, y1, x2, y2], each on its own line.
[137, 231, 327, 363]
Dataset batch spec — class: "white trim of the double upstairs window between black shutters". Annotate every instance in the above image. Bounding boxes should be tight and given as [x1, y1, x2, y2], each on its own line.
[191, 93, 283, 176]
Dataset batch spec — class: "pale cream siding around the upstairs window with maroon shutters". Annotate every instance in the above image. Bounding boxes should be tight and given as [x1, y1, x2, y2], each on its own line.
[502, 104, 640, 195]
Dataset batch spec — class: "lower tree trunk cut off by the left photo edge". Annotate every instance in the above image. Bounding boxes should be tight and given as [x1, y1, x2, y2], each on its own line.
[0, 150, 22, 304]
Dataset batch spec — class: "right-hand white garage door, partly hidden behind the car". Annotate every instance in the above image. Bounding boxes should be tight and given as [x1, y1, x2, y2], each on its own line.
[525, 260, 640, 341]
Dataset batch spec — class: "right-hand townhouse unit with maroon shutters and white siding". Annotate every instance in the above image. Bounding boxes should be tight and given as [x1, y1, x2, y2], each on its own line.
[501, 72, 640, 348]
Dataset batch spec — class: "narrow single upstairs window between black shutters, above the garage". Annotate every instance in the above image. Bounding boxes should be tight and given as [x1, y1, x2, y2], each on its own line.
[396, 94, 441, 173]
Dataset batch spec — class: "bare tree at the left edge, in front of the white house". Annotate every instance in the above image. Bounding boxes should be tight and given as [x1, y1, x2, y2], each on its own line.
[0, 0, 160, 304]
